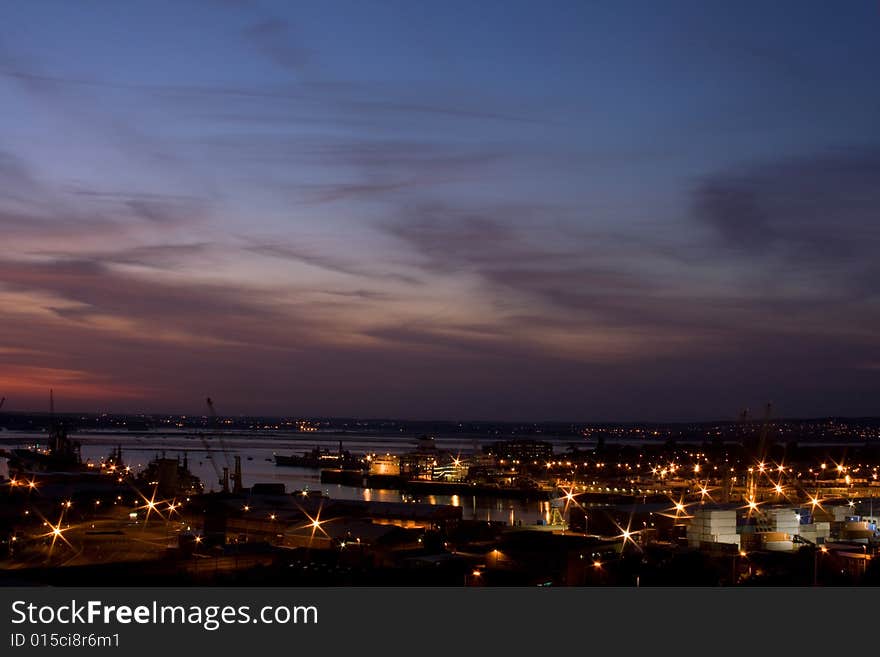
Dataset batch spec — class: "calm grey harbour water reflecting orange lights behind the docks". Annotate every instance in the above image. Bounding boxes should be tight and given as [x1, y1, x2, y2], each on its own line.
[0, 432, 550, 524]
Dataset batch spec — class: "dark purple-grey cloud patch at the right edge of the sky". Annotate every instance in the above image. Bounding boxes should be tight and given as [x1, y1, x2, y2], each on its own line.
[695, 147, 880, 295]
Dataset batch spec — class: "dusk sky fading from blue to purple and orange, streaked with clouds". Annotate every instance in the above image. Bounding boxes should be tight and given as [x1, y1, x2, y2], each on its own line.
[0, 0, 880, 421]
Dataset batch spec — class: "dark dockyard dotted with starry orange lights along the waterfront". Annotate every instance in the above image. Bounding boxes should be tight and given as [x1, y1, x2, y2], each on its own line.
[0, 410, 880, 585]
